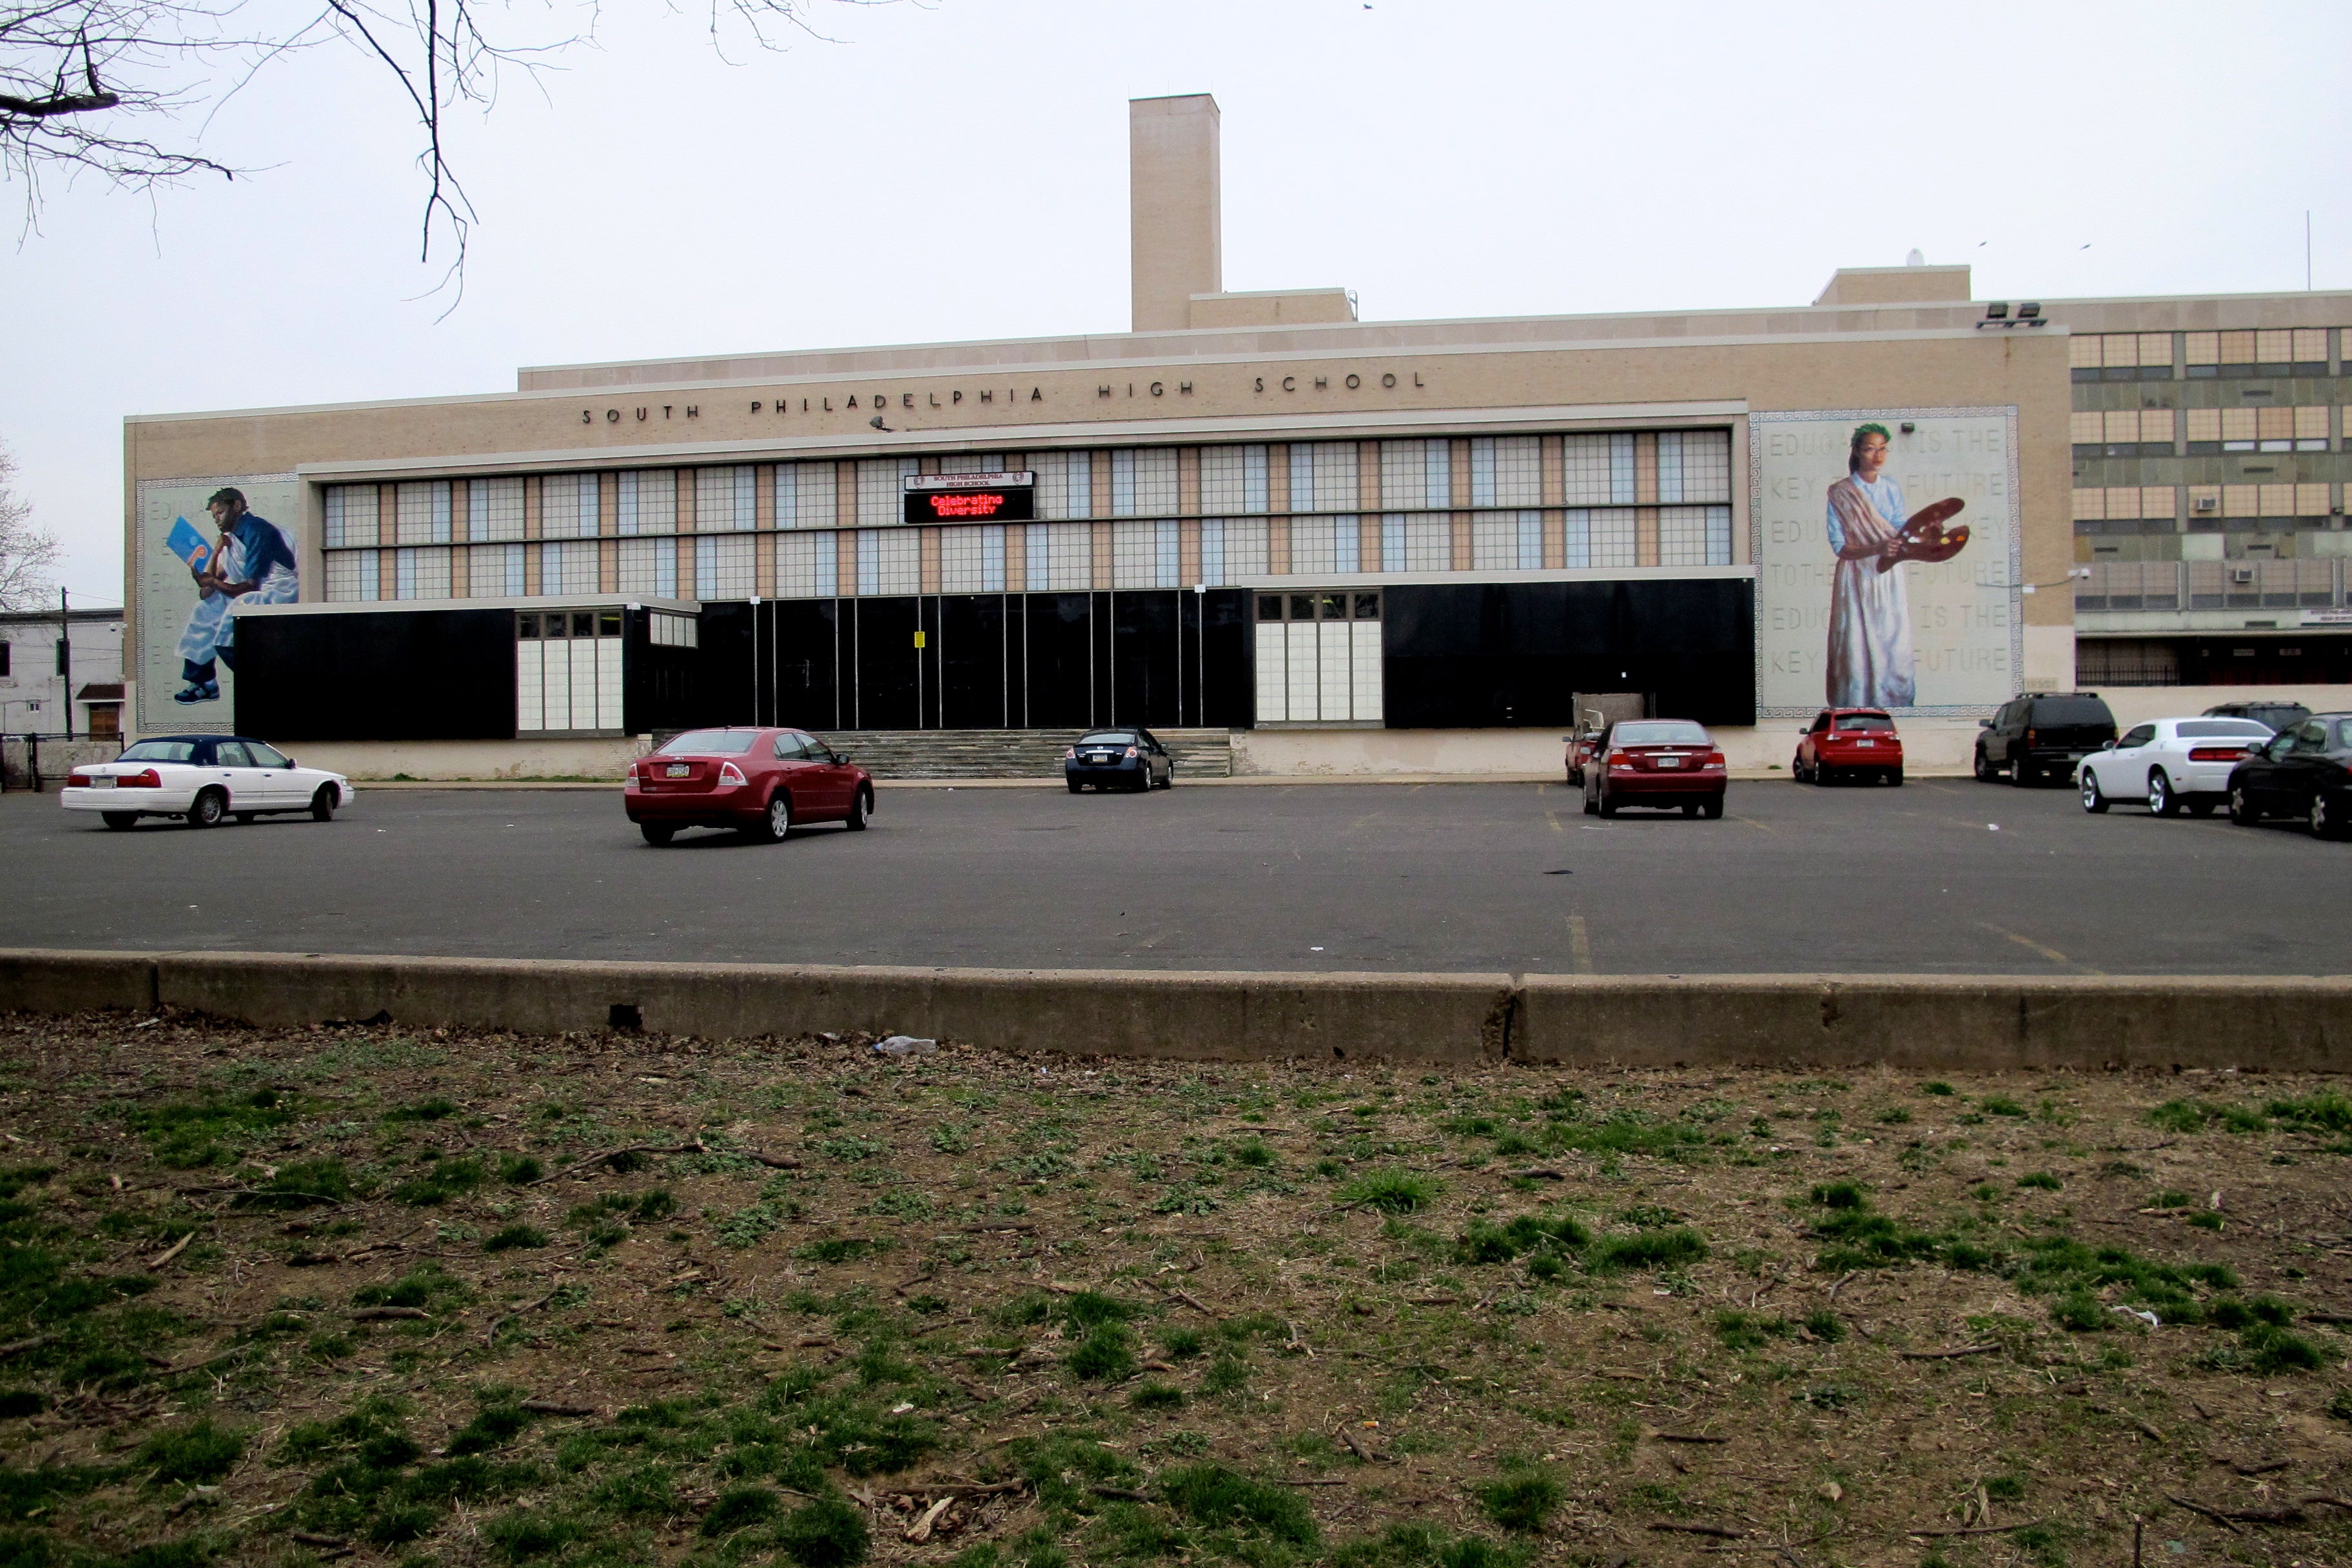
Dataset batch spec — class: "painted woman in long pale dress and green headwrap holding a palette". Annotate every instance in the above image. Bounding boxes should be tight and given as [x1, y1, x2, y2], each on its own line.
[1825, 426, 1968, 707]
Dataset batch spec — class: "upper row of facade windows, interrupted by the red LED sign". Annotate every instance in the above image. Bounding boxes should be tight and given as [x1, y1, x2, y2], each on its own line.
[327, 430, 1731, 550]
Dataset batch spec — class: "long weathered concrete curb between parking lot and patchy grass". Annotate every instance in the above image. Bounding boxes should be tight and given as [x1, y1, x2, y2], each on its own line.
[0, 947, 2352, 1072]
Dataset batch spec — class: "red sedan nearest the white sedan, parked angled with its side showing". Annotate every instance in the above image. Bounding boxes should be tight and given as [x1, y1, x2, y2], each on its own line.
[621, 729, 875, 844]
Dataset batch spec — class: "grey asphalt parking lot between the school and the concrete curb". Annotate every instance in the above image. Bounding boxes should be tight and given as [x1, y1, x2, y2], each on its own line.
[0, 781, 2352, 974]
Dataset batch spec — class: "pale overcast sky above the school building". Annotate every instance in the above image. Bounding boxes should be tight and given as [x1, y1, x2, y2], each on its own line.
[0, 0, 2352, 602]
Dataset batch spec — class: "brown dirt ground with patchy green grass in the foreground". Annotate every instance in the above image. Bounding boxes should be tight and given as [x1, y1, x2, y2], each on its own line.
[0, 1015, 2352, 1568]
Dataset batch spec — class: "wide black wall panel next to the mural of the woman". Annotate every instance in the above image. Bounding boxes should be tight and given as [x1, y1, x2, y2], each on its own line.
[1380, 578, 1754, 729]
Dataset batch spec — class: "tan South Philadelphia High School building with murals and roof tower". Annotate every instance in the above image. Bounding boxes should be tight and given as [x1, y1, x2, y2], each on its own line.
[124, 96, 2352, 776]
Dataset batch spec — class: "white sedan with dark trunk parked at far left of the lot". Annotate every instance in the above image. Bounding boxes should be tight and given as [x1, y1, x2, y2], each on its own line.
[57, 736, 355, 827]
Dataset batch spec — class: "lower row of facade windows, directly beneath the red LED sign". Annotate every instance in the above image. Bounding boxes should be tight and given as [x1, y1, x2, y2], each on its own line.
[327, 505, 1734, 602]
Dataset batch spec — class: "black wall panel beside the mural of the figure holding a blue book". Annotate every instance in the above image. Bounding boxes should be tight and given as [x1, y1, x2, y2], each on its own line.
[235, 609, 515, 743]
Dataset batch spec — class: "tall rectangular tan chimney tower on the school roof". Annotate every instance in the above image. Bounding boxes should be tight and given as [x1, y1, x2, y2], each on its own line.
[1126, 92, 1226, 331]
